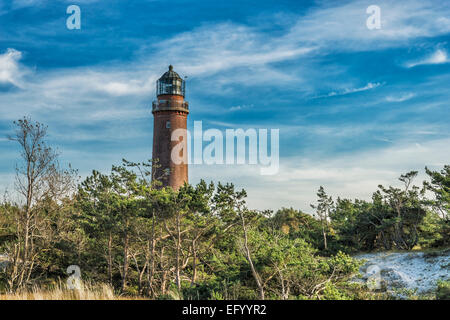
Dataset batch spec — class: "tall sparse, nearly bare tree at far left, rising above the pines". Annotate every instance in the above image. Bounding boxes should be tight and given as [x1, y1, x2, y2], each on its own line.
[8, 118, 76, 290]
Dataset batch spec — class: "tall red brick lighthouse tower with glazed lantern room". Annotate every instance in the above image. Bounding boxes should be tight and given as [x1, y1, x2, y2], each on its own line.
[152, 66, 189, 190]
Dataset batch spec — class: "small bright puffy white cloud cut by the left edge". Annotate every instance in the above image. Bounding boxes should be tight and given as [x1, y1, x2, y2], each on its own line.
[0, 49, 25, 88]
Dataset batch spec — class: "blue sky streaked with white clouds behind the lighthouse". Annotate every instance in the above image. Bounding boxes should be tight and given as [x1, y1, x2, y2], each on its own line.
[0, 0, 450, 211]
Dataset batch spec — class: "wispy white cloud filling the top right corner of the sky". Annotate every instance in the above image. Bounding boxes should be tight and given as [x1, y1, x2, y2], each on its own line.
[290, 0, 450, 51]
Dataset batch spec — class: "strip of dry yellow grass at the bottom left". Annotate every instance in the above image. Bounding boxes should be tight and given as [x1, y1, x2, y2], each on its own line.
[0, 283, 139, 300]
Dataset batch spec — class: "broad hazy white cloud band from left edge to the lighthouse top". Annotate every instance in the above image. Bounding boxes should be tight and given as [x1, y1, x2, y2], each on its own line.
[0, 66, 156, 127]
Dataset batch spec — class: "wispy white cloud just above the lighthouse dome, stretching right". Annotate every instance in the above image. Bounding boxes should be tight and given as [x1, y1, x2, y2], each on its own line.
[156, 23, 315, 84]
